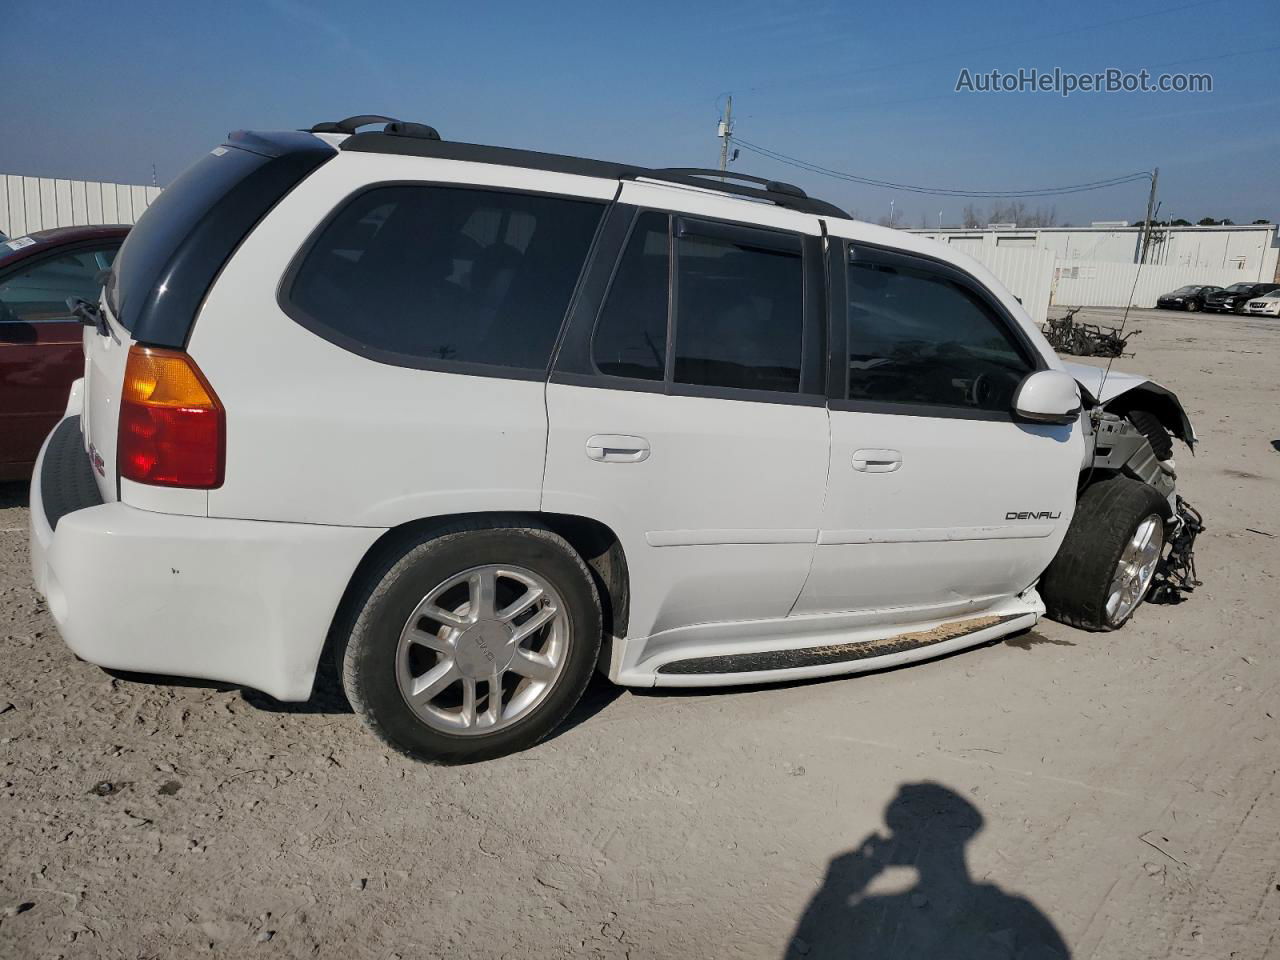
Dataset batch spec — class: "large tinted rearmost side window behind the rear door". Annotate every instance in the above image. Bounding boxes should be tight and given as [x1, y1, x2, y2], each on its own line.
[285, 184, 604, 370]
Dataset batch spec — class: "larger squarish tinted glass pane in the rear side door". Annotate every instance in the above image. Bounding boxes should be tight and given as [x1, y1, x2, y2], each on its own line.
[675, 236, 804, 393]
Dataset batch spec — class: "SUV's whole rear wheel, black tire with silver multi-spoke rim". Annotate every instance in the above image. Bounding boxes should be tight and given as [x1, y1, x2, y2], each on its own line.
[337, 522, 600, 763]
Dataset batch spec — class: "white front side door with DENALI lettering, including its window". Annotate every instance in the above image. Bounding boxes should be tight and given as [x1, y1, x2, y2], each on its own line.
[796, 236, 1083, 621]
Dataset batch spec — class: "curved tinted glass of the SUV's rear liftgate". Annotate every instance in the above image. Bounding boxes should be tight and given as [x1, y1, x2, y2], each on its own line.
[106, 147, 269, 330]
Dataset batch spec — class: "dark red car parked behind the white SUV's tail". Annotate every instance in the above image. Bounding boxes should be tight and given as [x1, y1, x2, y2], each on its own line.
[0, 225, 129, 480]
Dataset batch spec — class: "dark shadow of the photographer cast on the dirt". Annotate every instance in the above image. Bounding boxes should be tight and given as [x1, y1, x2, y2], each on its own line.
[785, 782, 1070, 960]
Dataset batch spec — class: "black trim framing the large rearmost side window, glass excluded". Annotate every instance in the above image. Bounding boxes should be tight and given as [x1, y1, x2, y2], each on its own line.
[275, 178, 613, 381]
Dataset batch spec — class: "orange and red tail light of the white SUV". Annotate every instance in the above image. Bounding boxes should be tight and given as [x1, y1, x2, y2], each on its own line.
[116, 344, 227, 489]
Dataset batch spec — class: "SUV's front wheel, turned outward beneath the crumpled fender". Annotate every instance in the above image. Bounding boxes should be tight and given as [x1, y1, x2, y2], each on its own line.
[1039, 476, 1166, 631]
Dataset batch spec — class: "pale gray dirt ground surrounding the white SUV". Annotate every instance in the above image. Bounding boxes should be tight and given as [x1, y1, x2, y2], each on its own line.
[0, 311, 1280, 960]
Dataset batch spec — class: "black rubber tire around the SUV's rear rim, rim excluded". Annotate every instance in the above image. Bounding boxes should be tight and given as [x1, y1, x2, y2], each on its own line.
[334, 520, 602, 764]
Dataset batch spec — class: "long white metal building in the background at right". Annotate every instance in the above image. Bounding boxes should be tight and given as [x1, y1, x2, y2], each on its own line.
[911, 224, 1280, 283]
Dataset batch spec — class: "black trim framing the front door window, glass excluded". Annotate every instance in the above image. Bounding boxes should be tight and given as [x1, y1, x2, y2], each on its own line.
[827, 237, 1050, 422]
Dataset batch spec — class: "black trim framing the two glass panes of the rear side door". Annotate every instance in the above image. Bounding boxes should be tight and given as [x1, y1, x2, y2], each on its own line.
[550, 204, 827, 407]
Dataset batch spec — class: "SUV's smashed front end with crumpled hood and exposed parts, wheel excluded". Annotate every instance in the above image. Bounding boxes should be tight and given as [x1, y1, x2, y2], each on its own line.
[1064, 362, 1204, 603]
